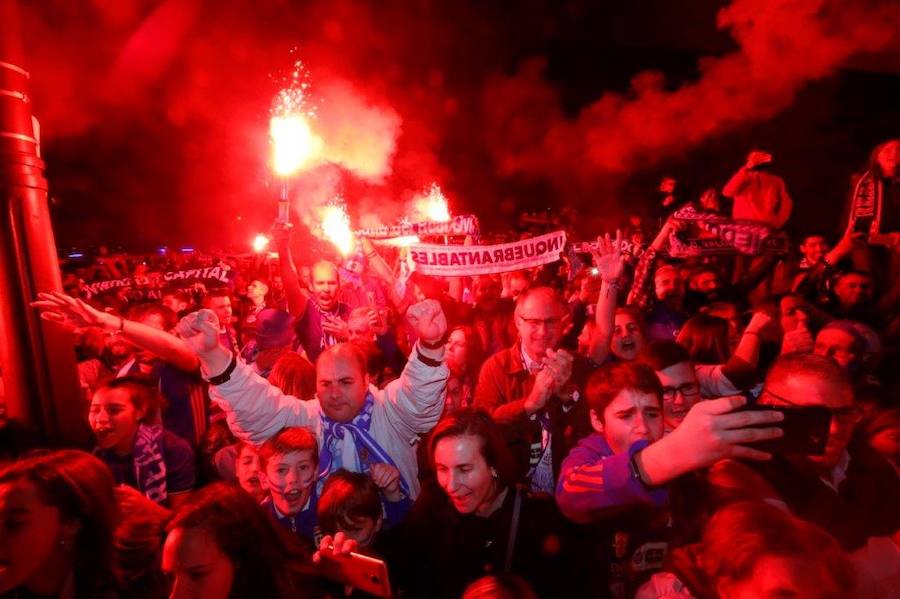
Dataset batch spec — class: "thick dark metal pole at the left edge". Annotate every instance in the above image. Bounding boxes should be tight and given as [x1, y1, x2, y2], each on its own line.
[0, 0, 87, 444]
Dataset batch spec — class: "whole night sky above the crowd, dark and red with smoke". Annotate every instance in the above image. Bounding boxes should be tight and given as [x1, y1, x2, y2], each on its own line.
[20, 0, 900, 249]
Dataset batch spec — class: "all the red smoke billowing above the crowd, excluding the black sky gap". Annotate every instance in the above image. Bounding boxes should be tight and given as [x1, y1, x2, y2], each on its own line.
[14, 0, 897, 244]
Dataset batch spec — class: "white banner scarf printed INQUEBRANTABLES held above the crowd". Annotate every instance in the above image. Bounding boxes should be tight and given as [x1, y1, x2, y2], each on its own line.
[409, 231, 566, 277]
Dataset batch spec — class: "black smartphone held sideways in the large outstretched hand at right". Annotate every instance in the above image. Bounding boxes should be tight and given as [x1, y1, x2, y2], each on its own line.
[742, 405, 831, 455]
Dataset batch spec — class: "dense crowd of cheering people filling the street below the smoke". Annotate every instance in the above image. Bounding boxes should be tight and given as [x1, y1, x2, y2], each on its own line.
[0, 140, 900, 599]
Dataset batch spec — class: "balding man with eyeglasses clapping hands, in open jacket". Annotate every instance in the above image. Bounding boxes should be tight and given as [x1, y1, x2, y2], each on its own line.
[474, 287, 591, 493]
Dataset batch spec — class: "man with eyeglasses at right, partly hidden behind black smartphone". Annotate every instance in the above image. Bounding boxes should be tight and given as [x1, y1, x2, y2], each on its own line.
[710, 354, 900, 552]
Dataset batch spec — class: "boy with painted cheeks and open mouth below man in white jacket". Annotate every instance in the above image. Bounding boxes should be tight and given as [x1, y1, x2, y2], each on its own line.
[259, 426, 319, 542]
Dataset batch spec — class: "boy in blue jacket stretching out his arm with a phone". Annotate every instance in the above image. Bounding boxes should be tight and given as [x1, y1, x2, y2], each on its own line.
[556, 362, 781, 598]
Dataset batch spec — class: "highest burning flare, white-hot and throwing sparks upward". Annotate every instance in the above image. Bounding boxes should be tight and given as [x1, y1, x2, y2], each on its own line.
[269, 60, 322, 177]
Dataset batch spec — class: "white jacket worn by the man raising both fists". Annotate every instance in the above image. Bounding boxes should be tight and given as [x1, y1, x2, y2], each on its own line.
[209, 346, 450, 499]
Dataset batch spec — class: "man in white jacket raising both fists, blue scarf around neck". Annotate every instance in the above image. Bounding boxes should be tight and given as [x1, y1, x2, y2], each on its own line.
[178, 300, 449, 499]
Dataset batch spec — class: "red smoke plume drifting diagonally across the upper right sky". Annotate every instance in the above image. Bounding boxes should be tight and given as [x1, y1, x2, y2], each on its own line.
[483, 0, 900, 186]
